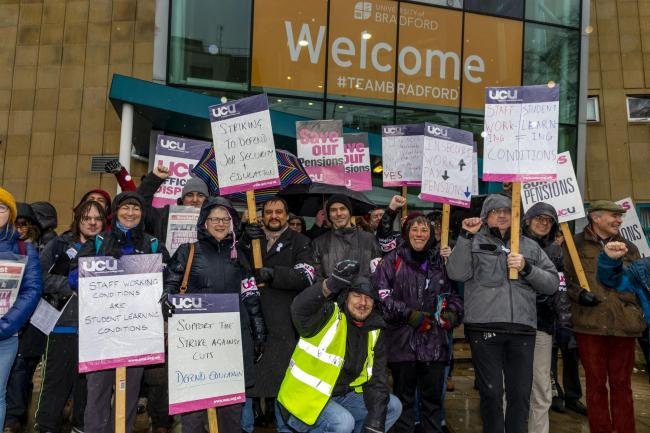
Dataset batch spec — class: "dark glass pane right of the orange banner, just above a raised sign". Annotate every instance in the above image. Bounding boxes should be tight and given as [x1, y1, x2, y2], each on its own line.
[523, 23, 580, 124]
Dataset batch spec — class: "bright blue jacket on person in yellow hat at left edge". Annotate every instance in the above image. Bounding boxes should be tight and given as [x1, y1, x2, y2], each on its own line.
[0, 224, 43, 340]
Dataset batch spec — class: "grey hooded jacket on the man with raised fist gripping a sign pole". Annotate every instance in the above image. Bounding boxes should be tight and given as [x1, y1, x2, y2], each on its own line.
[447, 194, 560, 334]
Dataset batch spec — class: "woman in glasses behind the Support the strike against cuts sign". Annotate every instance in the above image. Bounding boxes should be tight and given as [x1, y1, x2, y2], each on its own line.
[165, 197, 266, 433]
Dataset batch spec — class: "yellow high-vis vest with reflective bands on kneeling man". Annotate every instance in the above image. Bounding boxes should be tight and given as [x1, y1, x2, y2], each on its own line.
[278, 303, 379, 425]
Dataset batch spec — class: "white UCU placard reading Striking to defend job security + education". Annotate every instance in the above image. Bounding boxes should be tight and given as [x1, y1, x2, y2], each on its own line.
[210, 94, 280, 195]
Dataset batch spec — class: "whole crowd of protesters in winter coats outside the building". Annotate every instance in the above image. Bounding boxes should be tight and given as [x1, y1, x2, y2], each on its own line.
[0, 162, 650, 433]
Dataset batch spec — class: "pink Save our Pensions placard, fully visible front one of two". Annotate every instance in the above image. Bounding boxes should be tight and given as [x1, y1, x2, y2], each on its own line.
[296, 120, 345, 185]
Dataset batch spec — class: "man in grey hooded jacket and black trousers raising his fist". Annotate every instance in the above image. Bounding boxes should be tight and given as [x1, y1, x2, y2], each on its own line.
[447, 194, 560, 433]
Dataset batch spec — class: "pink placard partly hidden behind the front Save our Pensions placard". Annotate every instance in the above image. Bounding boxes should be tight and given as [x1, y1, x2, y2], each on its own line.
[343, 132, 372, 191]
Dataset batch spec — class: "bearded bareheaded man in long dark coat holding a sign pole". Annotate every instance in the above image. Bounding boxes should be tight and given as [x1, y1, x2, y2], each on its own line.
[242, 197, 314, 433]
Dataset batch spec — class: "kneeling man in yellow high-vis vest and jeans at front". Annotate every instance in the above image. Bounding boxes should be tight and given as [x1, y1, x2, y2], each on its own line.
[278, 260, 402, 433]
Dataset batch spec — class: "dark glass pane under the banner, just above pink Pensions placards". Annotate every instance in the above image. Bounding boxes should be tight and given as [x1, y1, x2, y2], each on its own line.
[325, 102, 393, 133]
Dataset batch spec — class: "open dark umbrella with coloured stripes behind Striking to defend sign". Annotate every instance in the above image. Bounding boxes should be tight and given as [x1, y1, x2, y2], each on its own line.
[192, 147, 311, 204]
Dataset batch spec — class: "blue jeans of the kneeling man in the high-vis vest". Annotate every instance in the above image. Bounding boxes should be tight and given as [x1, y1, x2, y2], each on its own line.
[287, 392, 402, 433]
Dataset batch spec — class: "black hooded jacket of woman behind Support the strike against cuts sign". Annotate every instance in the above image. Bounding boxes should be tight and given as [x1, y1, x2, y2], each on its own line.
[164, 197, 266, 386]
